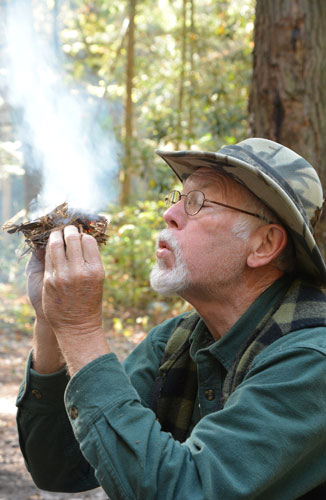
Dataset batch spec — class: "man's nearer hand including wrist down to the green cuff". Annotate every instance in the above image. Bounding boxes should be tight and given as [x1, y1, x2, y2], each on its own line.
[43, 226, 109, 374]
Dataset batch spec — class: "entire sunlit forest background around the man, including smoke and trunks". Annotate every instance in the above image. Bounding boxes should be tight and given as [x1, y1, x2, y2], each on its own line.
[0, 0, 326, 500]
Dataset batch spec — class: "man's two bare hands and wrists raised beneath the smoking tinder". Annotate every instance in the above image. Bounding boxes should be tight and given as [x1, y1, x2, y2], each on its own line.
[26, 226, 109, 375]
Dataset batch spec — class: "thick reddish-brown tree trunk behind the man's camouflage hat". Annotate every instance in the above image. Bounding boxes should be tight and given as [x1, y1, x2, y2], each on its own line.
[249, 0, 326, 257]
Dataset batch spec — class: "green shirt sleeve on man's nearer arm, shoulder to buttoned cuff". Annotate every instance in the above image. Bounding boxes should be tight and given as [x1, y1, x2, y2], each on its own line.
[65, 331, 326, 500]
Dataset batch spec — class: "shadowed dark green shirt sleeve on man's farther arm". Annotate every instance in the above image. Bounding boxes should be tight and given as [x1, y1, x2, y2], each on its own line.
[16, 352, 98, 492]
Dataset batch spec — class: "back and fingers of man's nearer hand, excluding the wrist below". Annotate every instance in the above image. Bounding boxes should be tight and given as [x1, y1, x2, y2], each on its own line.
[42, 226, 104, 337]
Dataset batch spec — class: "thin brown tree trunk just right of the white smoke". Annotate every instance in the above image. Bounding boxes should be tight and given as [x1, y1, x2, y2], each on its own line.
[120, 0, 136, 205]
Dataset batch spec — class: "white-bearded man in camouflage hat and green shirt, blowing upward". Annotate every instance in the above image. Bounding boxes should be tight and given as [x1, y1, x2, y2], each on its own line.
[17, 139, 326, 500]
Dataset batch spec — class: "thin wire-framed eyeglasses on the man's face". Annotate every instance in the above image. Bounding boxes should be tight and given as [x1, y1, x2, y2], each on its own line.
[165, 189, 272, 224]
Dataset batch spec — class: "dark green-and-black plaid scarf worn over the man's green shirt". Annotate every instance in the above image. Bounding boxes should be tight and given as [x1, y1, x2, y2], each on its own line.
[151, 280, 326, 444]
